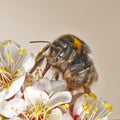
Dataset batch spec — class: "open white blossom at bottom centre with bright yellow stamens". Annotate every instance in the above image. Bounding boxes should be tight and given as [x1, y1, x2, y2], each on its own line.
[1, 87, 72, 120]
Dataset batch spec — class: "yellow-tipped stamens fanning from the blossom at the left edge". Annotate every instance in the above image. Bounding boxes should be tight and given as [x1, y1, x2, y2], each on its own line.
[0, 40, 26, 90]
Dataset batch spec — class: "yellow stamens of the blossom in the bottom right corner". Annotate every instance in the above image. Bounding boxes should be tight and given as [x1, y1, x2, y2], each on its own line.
[83, 93, 112, 120]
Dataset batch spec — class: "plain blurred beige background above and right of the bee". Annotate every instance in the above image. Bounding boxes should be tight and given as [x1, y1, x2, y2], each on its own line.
[0, 0, 120, 120]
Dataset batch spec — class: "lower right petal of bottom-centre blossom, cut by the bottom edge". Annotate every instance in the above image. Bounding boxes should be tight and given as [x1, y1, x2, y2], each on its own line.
[46, 108, 63, 120]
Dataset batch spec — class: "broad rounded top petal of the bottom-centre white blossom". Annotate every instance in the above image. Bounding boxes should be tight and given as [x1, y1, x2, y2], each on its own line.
[24, 87, 49, 105]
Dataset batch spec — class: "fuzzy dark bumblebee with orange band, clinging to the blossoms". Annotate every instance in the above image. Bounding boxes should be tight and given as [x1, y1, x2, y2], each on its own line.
[30, 34, 98, 93]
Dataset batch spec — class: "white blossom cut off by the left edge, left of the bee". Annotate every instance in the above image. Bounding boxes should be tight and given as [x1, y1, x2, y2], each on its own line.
[0, 40, 33, 102]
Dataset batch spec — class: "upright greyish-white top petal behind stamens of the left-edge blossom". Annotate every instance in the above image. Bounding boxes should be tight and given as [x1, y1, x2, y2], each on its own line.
[3, 40, 26, 73]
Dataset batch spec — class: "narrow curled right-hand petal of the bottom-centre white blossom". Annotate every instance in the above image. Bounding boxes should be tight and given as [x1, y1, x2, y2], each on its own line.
[45, 91, 72, 110]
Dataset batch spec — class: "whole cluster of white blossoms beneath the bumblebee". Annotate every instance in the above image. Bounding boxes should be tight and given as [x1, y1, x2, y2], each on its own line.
[0, 40, 112, 120]
